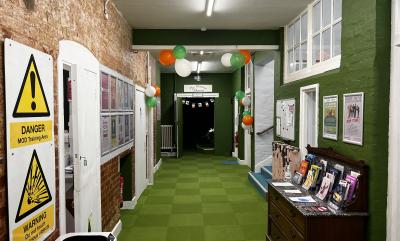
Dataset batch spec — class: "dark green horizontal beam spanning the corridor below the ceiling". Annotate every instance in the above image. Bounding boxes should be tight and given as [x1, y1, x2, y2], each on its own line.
[132, 29, 280, 45]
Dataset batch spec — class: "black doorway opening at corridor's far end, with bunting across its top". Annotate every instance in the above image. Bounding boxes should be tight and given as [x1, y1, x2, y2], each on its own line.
[182, 98, 214, 152]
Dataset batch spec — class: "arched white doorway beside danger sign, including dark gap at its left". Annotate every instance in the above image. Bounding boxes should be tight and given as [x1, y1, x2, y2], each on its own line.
[58, 40, 102, 234]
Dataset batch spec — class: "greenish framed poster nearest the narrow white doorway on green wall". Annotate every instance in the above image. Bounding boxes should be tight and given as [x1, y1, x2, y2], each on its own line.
[322, 95, 339, 140]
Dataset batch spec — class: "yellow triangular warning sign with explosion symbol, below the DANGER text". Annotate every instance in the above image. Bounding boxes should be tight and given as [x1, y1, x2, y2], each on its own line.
[15, 150, 52, 223]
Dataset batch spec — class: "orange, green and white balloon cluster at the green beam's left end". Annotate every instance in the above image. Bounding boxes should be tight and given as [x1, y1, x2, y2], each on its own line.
[159, 45, 192, 77]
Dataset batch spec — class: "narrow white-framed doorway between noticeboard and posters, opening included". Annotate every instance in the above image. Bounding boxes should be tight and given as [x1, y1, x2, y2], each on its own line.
[299, 84, 319, 159]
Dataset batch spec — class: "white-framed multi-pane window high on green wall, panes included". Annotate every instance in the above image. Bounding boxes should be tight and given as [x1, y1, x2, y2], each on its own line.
[284, 0, 342, 83]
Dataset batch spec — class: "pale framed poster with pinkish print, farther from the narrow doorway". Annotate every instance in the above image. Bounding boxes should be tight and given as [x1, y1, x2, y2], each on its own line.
[343, 92, 364, 146]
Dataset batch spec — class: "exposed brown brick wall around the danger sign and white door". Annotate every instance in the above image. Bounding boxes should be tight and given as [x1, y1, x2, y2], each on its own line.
[0, 0, 147, 240]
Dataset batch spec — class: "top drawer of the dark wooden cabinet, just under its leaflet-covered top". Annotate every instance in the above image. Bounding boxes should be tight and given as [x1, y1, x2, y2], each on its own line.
[268, 188, 306, 235]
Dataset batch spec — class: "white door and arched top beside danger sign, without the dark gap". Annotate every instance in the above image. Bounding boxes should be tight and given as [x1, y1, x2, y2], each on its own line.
[60, 41, 101, 232]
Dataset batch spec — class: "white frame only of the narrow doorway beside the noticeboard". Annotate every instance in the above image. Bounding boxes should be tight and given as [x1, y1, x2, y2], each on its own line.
[299, 84, 319, 159]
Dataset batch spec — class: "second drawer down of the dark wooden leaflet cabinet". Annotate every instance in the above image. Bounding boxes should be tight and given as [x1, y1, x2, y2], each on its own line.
[268, 203, 304, 241]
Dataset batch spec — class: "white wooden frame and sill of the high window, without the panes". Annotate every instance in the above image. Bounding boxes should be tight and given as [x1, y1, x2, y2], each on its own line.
[283, 0, 343, 84]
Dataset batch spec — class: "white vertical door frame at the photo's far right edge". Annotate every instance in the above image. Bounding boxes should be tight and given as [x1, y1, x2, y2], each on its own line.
[386, 0, 400, 241]
